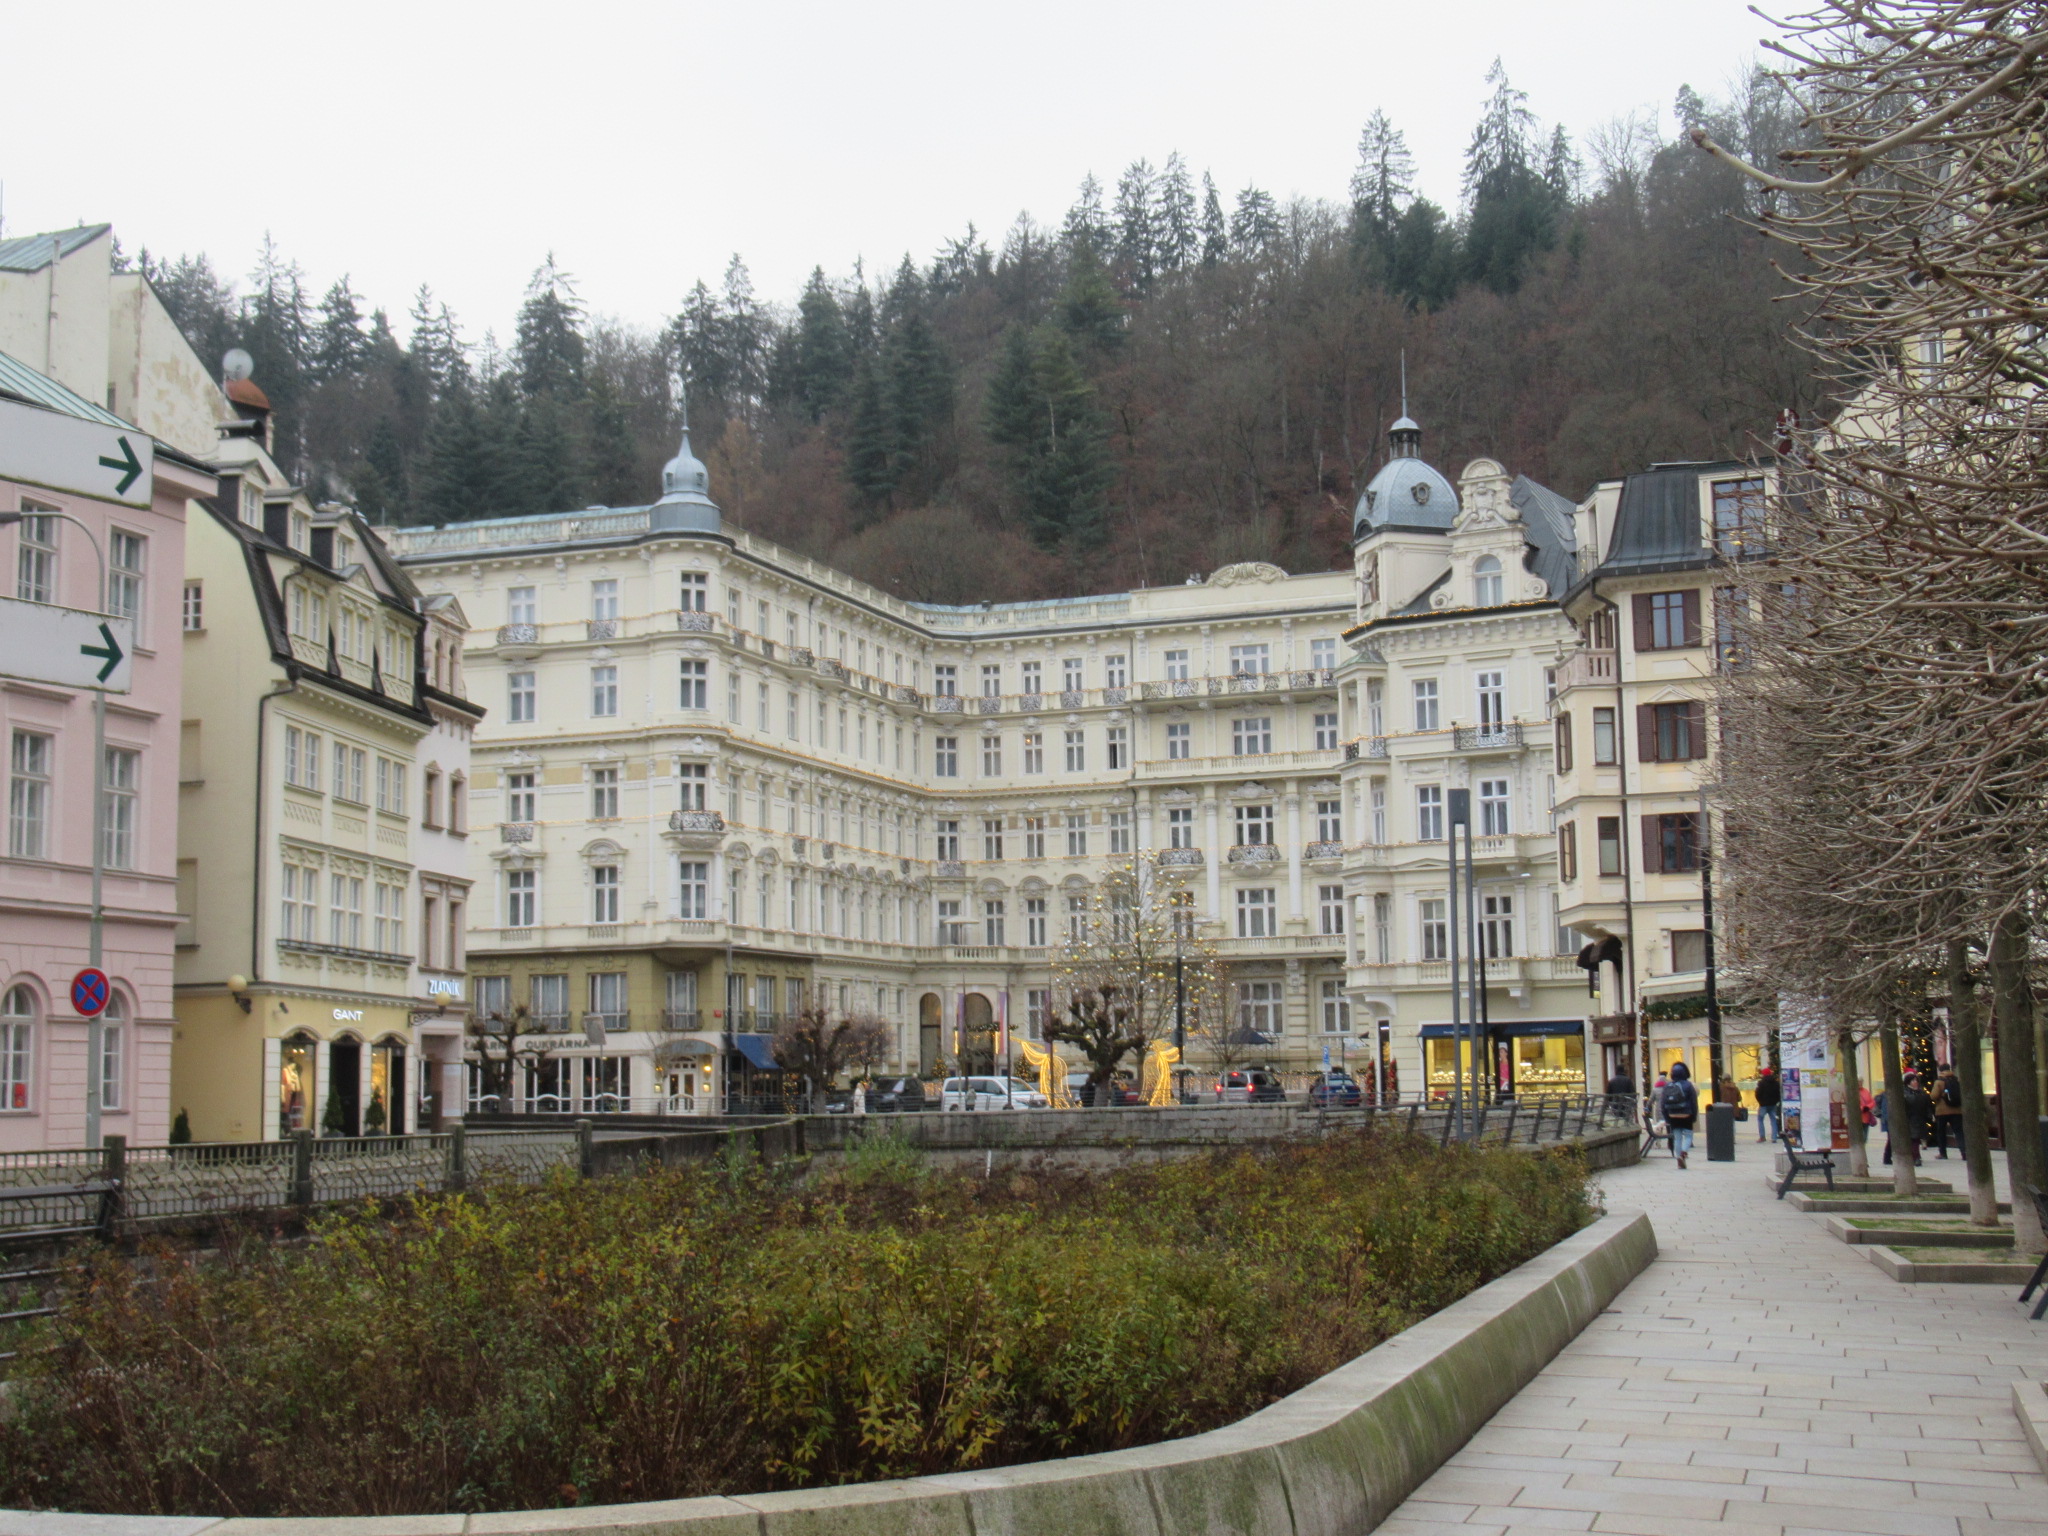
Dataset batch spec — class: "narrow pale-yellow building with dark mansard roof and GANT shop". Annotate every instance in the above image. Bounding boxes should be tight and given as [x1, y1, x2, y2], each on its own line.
[172, 424, 477, 1141]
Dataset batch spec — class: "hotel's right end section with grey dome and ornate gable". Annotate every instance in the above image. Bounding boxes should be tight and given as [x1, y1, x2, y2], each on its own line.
[1343, 438, 1587, 1094]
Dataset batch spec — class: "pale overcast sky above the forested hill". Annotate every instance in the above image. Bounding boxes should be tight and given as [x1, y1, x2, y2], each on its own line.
[0, 0, 1767, 340]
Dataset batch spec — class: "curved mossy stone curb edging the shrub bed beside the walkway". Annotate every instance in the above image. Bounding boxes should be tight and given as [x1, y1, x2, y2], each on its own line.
[0, 1212, 1657, 1536]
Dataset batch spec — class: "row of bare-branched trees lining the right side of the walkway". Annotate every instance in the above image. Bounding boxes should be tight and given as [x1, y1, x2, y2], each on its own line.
[1692, 0, 2048, 1251]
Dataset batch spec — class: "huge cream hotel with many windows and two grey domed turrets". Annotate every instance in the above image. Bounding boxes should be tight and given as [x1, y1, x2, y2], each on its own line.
[383, 418, 1589, 1112]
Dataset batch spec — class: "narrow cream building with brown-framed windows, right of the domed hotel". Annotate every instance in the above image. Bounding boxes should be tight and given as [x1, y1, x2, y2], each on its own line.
[1552, 461, 1774, 1090]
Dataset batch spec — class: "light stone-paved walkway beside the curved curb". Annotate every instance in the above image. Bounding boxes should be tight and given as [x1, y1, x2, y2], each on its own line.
[1378, 1126, 2048, 1536]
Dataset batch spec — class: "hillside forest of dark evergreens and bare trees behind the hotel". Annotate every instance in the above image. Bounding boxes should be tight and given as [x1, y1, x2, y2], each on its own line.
[139, 63, 1825, 602]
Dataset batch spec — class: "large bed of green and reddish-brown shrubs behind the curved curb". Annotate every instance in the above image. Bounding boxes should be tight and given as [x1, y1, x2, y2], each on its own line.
[0, 1135, 1589, 1516]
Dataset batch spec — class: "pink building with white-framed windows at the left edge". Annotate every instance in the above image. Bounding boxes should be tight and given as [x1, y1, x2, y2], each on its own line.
[0, 352, 215, 1151]
